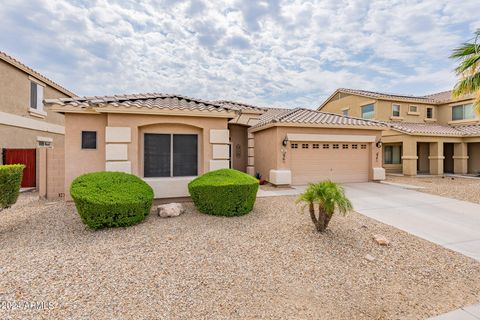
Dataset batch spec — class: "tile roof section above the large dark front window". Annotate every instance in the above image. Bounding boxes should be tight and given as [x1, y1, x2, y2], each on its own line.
[45, 93, 235, 117]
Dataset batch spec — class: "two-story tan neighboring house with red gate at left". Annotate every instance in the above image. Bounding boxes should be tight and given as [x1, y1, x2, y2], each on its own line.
[0, 51, 75, 195]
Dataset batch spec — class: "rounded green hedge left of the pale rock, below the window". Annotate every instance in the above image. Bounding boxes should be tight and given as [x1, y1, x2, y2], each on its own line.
[70, 172, 153, 229]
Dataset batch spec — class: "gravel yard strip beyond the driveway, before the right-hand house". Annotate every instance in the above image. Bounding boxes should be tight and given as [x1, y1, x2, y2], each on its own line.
[387, 175, 480, 203]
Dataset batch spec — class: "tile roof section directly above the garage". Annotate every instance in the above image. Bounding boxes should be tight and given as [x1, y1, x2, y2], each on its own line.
[254, 108, 385, 128]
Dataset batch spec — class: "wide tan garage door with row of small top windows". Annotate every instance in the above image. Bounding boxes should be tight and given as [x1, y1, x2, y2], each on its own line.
[290, 141, 370, 185]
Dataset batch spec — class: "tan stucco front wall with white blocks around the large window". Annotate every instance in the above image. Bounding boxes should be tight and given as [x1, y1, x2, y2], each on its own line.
[65, 113, 229, 198]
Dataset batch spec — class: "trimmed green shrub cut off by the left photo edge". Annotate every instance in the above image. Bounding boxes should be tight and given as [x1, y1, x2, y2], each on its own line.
[0, 164, 25, 209]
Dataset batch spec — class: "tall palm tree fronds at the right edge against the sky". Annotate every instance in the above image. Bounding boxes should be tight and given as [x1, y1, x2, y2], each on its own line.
[450, 29, 480, 114]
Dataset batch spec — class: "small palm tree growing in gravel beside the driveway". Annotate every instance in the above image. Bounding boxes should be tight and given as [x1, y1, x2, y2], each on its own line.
[297, 180, 353, 232]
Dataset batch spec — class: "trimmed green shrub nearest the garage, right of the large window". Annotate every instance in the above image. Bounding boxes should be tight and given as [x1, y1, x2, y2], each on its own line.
[188, 169, 258, 216]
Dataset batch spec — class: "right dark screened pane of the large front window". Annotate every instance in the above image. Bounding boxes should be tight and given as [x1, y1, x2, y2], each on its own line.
[173, 134, 198, 177]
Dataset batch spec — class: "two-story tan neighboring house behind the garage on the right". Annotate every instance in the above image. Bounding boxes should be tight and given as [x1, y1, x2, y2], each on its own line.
[318, 89, 480, 175]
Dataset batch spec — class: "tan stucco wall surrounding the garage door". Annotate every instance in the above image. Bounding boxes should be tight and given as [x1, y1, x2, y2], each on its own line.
[254, 126, 382, 180]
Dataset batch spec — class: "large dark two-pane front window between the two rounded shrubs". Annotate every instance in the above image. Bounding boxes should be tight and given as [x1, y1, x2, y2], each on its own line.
[143, 133, 198, 177]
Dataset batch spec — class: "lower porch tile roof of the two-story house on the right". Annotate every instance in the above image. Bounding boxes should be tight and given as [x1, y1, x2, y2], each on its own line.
[386, 122, 480, 136]
